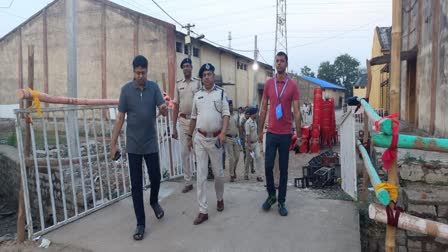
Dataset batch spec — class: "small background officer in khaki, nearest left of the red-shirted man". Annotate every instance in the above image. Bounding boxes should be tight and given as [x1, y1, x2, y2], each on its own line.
[244, 108, 263, 182]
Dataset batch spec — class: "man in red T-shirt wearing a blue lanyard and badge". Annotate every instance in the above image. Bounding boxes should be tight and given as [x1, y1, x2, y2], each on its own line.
[258, 52, 301, 216]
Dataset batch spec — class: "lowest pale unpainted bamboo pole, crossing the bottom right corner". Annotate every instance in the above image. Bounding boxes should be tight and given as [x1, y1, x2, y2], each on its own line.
[369, 203, 448, 240]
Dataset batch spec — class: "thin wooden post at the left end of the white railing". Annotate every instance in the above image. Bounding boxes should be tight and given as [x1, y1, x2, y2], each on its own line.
[17, 45, 34, 243]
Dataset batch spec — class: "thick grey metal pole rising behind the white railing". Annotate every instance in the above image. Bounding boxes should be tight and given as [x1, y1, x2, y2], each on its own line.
[65, 0, 79, 157]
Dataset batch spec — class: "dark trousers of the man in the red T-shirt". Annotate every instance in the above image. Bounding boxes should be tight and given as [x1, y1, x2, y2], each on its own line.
[264, 132, 292, 203]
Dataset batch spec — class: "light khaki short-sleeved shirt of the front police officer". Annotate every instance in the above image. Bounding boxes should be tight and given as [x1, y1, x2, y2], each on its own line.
[191, 85, 230, 132]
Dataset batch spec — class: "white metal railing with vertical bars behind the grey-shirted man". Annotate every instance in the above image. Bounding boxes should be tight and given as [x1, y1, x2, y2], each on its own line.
[15, 105, 183, 239]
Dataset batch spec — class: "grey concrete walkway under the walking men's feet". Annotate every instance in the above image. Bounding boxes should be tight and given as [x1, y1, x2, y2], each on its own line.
[44, 182, 361, 252]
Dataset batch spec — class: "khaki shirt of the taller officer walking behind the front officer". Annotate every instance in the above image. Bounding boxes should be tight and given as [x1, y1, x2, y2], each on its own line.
[173, 77, 201, 115]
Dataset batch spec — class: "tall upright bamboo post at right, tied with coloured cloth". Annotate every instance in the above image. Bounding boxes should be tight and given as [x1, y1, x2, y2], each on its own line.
[385, 0, 402, 252]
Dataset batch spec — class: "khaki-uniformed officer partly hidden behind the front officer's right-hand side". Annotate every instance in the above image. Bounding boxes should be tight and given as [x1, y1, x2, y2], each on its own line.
[225, 100, 240, 182]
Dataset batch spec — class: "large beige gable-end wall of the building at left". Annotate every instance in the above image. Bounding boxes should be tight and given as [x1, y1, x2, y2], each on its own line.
[0, 0, 175, 104]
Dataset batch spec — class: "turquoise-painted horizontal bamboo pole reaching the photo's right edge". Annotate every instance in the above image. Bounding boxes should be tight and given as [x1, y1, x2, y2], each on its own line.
[373, 133, 448, 152]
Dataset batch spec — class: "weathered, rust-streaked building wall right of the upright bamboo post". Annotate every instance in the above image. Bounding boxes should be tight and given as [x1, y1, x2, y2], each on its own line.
[400, 0, 448, 137]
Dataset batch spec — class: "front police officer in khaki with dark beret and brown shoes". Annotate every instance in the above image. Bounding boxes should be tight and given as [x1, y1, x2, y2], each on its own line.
[188, 63, 230, 225]
